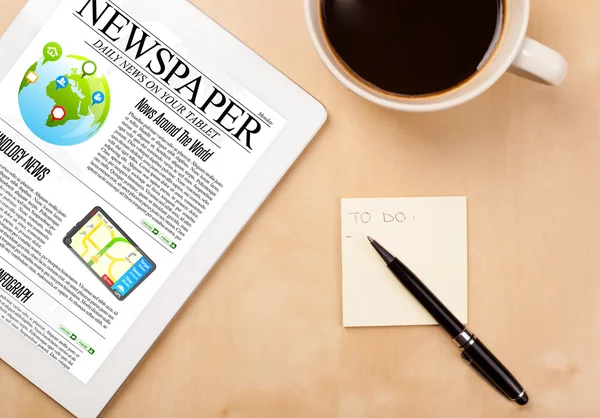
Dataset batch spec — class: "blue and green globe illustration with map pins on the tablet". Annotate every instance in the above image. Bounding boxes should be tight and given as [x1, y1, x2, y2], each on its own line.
[19, 42, 110, 146]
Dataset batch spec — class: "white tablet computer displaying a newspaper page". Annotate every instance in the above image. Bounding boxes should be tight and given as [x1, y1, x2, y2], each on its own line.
[0, 0, 326, 417]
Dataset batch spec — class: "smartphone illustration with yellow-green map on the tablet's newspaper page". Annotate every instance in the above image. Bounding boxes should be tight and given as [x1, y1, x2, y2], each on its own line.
[63, 207, 156, 300]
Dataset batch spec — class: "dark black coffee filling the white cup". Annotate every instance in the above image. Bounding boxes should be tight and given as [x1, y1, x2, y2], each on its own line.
[321, 0, 503, 95]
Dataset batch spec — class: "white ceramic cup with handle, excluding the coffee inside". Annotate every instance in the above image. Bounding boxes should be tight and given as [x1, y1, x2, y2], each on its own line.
[304, 0, 567, 112]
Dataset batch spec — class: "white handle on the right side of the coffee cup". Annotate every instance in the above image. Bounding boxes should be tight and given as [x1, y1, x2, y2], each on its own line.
[508, 38, 568, 86]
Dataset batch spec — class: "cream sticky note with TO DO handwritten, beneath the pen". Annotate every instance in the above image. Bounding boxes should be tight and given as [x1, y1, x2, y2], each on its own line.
[342, 197, 467, 327]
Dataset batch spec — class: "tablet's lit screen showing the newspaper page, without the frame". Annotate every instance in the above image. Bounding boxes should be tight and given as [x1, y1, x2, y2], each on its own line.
[0, 0, 286, 383]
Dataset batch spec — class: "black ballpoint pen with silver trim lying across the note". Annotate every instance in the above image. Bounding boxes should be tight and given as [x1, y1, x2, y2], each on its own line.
[367, 237, 529, 405]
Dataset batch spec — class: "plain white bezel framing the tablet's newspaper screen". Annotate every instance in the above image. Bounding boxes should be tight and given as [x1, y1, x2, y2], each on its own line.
[0, 0, 327, 417]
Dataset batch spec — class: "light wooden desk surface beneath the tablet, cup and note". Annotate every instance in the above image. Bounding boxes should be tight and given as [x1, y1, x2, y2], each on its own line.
[0, 0, 600, 418]
